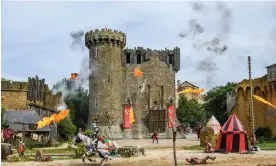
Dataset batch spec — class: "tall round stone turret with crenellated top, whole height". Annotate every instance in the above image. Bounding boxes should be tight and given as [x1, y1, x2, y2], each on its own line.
[85, 29, 126, 138]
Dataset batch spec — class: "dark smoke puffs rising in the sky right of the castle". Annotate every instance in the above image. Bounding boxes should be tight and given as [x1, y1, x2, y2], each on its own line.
[179, 1, 232, 84]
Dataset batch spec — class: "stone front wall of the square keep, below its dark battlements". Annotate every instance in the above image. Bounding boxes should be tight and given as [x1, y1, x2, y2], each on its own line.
[122, 51, 175, 138]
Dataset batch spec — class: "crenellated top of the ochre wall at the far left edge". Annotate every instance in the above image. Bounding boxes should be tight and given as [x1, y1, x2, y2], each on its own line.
[1, 81, 28, 91]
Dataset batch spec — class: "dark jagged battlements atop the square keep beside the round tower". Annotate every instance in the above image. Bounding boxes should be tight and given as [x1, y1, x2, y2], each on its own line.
[122, 47, 180, 72]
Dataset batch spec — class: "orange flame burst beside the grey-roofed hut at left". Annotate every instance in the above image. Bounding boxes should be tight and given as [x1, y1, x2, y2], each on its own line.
[37, 109, 70, 129]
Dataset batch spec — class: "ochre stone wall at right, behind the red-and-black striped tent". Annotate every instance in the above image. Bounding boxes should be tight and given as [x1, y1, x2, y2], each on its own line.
[233, 76, 276, 136]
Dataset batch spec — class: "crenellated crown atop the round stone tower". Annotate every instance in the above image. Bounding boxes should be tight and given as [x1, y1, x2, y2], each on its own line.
[85, 29, 126, 49]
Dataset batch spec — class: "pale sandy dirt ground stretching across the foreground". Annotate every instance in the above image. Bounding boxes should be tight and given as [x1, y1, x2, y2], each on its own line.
[1, 135, 276, 166]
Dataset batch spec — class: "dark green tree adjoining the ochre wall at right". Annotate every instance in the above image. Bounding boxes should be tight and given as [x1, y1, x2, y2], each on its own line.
[203, 82, 237, 124]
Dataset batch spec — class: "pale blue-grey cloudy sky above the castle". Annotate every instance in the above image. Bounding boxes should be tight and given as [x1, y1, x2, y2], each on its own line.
[2, 1, 276, 89]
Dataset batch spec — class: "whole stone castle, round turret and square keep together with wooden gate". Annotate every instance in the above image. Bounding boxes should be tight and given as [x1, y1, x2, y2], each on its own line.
[85, 29, 180, 139]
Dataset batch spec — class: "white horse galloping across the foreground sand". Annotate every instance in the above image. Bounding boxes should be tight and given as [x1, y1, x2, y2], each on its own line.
[74, 133, 118, 165]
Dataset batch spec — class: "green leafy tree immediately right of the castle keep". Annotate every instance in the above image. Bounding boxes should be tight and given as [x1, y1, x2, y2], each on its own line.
[176, 94, 206, 125]
